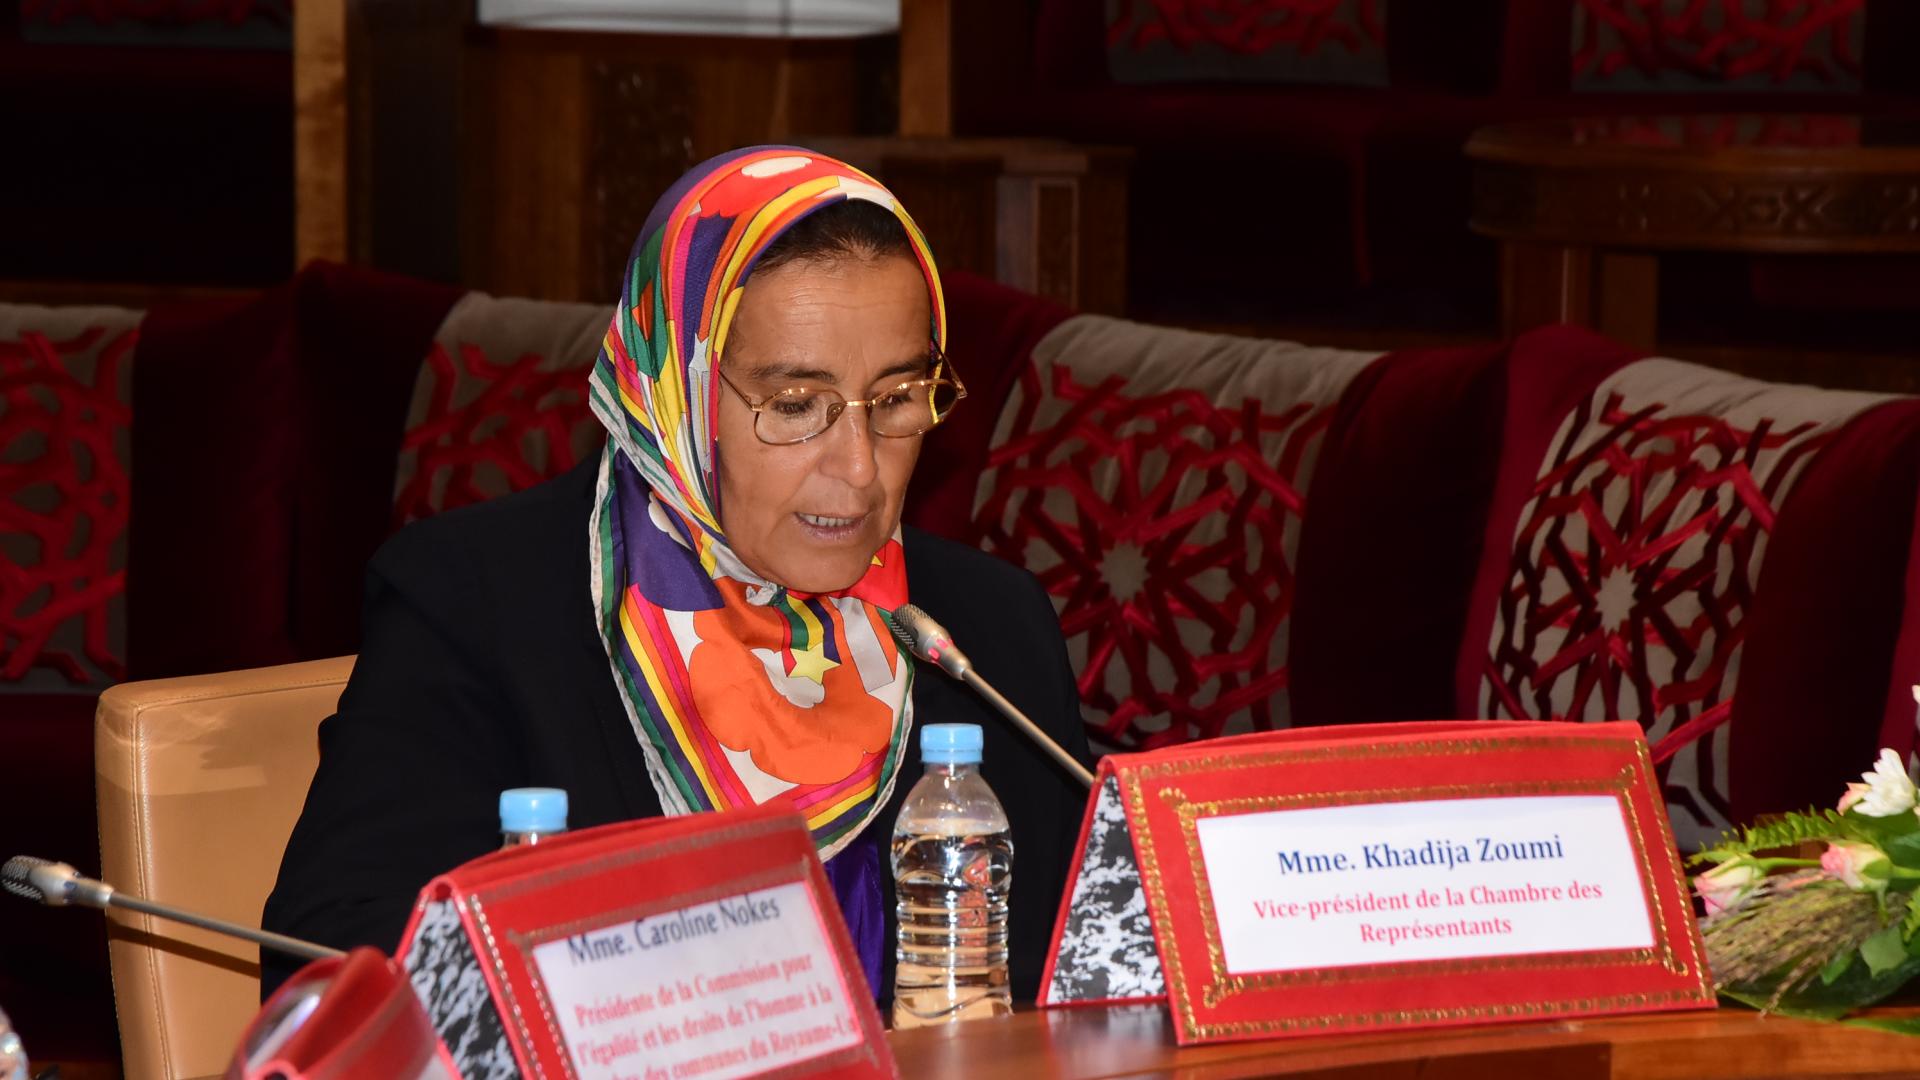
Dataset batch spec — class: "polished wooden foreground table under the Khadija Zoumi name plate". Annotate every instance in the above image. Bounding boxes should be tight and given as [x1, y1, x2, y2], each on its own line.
[889, 1005, 1920, 1080]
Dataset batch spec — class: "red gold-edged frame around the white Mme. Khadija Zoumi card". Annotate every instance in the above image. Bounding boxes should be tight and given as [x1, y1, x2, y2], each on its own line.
[1043, 721, 1715, 1043]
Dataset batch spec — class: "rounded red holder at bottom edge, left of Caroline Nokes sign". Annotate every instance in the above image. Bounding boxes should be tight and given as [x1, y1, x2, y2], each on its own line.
[227, 949, 459, 1080]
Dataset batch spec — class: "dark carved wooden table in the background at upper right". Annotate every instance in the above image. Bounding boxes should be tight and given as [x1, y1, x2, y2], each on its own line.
[1467, 115, 1920, 348]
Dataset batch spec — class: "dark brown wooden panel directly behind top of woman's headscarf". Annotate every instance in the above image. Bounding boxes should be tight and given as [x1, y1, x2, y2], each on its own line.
[463, 31, 858, 300]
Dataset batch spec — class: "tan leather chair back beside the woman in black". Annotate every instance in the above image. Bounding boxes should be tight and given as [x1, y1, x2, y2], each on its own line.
[94, 657, 353, 1080]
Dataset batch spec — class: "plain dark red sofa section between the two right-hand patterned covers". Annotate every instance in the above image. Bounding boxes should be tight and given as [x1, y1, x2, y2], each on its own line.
[1288, 342, 1507, 724]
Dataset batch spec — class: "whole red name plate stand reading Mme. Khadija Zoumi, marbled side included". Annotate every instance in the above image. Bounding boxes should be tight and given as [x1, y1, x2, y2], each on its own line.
[1041, 721, 1715, 1043]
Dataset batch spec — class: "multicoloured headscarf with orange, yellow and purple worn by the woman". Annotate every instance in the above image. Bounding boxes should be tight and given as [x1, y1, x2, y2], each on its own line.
[589, 146, 947, 859]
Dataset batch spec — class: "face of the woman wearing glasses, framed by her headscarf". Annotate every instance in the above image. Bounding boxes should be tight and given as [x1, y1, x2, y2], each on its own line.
[718, 256, 931, 592]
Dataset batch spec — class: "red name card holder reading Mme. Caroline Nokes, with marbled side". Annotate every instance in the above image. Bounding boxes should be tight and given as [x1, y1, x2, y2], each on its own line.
[399, 805, 895, 1080]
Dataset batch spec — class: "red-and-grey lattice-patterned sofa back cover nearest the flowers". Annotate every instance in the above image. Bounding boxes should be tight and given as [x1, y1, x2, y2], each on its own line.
[1473, 359, 1897, 844]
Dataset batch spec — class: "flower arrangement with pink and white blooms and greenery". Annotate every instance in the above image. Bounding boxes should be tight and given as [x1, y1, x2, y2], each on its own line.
[1692, 749, 1920, 1019]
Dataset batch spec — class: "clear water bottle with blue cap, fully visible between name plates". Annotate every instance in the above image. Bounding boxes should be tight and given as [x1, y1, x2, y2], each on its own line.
[893, 724, 1014, 1028]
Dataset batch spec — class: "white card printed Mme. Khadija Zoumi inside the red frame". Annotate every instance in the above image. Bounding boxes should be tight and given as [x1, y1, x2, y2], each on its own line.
[1194, 796, 1653, 974]
